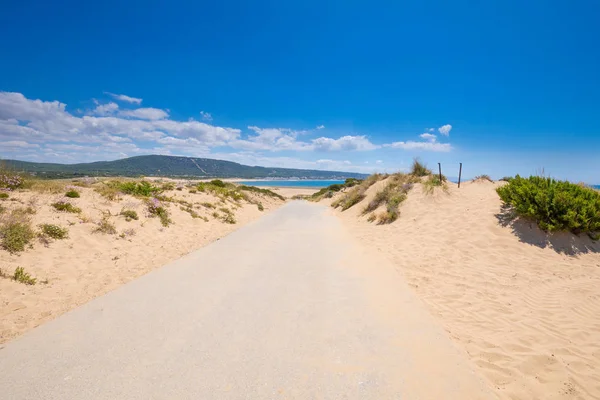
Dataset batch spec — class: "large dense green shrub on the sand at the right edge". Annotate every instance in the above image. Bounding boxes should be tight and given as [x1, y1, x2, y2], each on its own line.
[496, 175, 600, 235]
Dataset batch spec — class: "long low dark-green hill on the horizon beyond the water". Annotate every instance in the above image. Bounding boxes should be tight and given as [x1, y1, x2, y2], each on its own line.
[2, 155, 366, 179]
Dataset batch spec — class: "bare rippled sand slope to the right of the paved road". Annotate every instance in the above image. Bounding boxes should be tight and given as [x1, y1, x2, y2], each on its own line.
[328, 182, 600, 399]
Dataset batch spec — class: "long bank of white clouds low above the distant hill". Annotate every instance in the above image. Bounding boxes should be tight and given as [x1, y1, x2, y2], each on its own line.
[0, 92, 452, 170]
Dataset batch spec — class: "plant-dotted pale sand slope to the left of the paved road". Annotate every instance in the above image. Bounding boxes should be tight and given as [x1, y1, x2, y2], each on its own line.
[0, 188, 283, 343]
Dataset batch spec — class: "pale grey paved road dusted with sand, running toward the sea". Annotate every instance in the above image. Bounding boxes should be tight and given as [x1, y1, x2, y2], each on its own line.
[0, 202, 495, 400]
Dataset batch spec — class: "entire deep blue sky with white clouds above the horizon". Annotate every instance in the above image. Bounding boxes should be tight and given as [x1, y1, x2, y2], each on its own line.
[0, 1, 600, 183]
